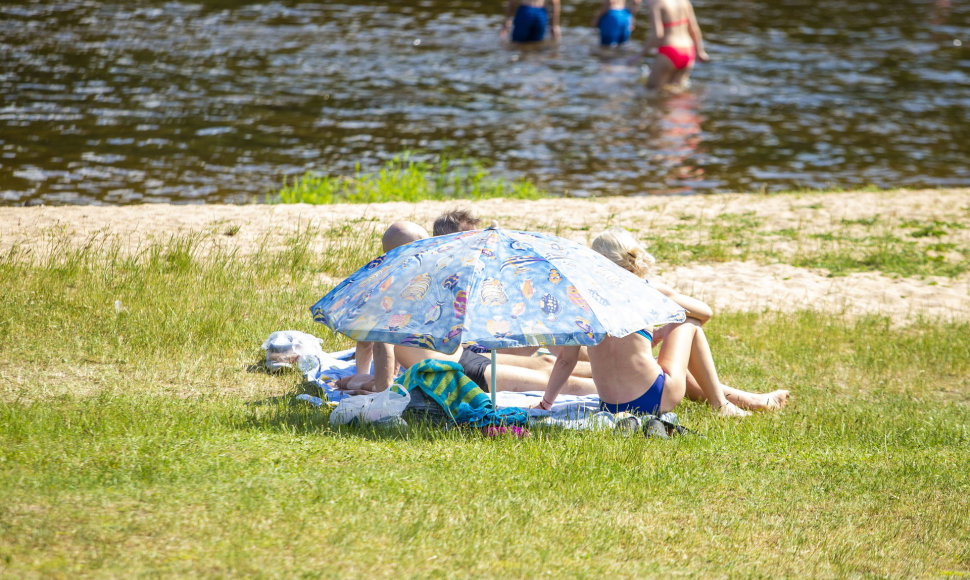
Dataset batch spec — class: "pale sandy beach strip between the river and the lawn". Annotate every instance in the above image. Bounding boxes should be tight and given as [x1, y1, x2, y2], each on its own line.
[0, 189, 970, 323]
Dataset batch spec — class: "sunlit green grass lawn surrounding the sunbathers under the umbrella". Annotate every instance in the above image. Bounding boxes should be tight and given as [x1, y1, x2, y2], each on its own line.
[0, 208, 970, 578]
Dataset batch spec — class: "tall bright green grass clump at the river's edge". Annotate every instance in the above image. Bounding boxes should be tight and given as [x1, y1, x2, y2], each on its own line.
[267, 153, 544, 204]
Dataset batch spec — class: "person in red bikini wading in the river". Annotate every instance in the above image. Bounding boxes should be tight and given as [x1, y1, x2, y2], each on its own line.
[630, 0, 709, 89]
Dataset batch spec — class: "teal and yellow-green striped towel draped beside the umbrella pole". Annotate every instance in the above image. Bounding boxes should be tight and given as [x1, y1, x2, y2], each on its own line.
[391, 359, 492, 421]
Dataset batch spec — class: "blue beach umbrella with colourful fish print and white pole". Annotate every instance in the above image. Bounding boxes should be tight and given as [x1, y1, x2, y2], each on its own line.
[310, 227, 684, 404]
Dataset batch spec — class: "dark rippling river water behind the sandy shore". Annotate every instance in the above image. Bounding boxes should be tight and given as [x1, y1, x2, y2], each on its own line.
[0, 0, 970, 205]
